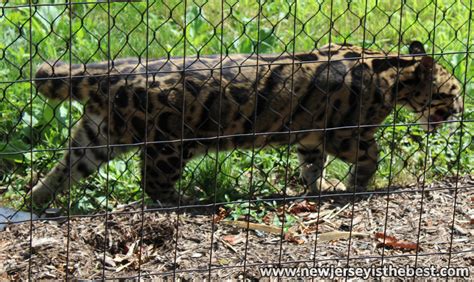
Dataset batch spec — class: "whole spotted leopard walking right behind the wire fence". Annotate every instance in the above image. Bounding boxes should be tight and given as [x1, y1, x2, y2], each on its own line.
[33, 42, 463, 206]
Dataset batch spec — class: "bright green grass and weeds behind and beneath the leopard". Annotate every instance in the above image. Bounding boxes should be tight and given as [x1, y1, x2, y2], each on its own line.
[0, 0, 474, 212]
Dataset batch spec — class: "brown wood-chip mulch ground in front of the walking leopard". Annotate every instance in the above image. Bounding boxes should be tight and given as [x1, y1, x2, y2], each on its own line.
[0, 176, 474, 279]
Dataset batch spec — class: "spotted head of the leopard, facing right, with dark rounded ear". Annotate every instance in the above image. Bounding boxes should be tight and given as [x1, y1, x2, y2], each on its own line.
[405, 41, 463, 131]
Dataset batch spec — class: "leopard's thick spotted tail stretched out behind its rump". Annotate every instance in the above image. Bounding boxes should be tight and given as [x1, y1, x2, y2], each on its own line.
[34, 62, 107, 101]
